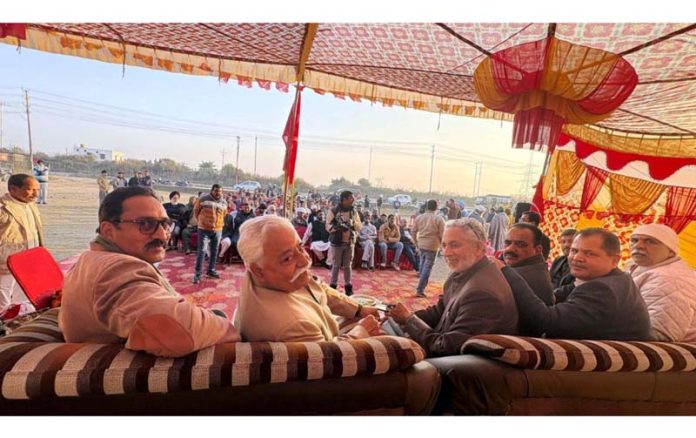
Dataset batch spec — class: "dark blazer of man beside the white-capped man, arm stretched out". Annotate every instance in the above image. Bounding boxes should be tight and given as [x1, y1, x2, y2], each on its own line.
[503, 267, 653, 341]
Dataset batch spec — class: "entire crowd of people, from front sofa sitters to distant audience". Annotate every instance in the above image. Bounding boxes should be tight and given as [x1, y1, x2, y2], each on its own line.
[0, 174, 696, 364]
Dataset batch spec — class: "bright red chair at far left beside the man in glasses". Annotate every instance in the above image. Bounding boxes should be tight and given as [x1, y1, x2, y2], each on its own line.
[7, 246, 63, 310]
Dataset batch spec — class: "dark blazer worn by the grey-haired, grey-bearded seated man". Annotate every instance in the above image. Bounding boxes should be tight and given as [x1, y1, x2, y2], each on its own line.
[405, 258, 517, 357]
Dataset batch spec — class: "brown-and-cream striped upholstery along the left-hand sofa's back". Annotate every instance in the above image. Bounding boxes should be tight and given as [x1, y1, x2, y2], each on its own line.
[0, 309, 425, 399]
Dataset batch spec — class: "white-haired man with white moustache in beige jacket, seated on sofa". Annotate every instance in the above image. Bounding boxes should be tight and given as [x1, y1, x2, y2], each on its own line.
[234, 216, 380, 342]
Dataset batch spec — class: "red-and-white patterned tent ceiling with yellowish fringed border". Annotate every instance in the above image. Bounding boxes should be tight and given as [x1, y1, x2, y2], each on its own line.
[0, 23, 696, 137]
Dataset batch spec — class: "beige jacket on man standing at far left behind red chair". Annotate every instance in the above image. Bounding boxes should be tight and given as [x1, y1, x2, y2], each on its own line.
[0, 193, 44, 275]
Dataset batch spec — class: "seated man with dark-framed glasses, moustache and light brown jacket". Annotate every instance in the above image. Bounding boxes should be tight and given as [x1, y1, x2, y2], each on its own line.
[58, 186, 239, 357]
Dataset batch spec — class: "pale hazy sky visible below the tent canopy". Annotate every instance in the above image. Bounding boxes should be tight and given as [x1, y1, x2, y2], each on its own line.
[0, 0, 676, 195]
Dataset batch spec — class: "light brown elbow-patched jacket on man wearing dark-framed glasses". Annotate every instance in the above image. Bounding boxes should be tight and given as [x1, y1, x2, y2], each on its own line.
[58, 242, 239, 357]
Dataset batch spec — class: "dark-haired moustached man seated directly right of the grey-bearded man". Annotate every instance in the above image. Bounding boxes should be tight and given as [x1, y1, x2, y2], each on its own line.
[503, 223, 553, 306]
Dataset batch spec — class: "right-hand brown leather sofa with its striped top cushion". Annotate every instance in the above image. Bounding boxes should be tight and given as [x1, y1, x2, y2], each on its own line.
[428, 335, 696, 415]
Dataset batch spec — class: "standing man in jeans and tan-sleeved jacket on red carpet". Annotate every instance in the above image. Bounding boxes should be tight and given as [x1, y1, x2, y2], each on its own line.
[193, 184, 227, 284]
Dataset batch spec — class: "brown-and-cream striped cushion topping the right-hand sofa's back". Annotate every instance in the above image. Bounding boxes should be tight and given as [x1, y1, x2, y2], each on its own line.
[462, 335, 696, 372]
